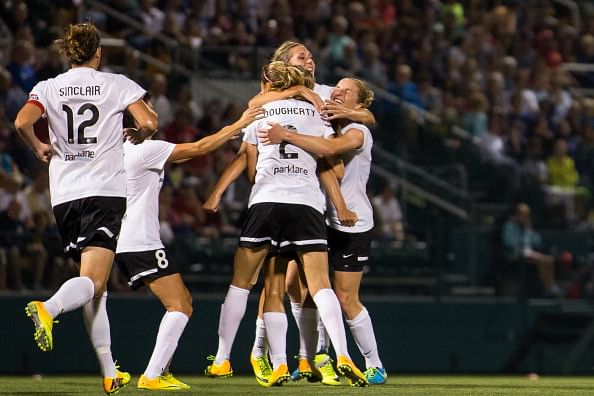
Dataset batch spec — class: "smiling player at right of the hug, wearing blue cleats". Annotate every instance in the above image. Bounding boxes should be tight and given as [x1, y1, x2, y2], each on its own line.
[258, 78, 387, 384]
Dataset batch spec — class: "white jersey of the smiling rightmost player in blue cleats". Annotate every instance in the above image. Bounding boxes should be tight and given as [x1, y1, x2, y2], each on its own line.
[326, 123, 373, 233]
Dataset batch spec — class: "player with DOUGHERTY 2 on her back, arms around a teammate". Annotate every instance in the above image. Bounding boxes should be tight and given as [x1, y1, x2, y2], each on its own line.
[206, 61, 367, 386]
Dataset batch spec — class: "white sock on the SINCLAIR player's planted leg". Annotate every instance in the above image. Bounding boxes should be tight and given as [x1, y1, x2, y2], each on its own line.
[83, 290, 116, 378]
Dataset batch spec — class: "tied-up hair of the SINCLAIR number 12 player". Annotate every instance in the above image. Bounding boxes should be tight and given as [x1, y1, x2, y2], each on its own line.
[55, 22, 101, 65]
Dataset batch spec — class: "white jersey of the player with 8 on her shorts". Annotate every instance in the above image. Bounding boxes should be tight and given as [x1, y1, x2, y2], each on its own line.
[116, 140, 175, 253]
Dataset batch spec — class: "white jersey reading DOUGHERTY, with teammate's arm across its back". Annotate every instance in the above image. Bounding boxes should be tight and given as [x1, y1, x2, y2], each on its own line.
[244, 99, 334, 213]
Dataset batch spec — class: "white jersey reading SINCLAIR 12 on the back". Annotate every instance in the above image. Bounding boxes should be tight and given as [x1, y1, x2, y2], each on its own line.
[29, 67, 145, 206]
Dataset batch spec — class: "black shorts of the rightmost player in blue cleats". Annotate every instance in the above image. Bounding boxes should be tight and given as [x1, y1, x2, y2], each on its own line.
[328, 227, 371, 272]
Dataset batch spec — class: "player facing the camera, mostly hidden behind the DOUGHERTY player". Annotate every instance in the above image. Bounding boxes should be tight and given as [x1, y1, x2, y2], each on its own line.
[204, 41, 375, 385]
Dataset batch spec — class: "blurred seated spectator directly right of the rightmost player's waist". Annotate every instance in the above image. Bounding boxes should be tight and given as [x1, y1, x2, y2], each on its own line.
[372, 184, 404, 242]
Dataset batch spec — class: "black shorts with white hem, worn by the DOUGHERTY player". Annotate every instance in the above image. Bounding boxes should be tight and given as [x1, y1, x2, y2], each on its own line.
[239, 202, 328, 254]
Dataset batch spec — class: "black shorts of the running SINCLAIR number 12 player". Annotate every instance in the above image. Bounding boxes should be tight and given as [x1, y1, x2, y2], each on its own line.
[53, 197, 126, 261]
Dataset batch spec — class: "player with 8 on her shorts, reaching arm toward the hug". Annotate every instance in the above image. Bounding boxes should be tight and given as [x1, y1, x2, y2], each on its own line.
[116, 96, 264, 390]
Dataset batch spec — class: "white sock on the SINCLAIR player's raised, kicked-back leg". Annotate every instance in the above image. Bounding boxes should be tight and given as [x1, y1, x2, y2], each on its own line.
[43, 276, 95, 318]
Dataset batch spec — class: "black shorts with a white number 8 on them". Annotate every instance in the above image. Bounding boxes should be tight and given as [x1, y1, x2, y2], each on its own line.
[116, 249, 179, 289]
